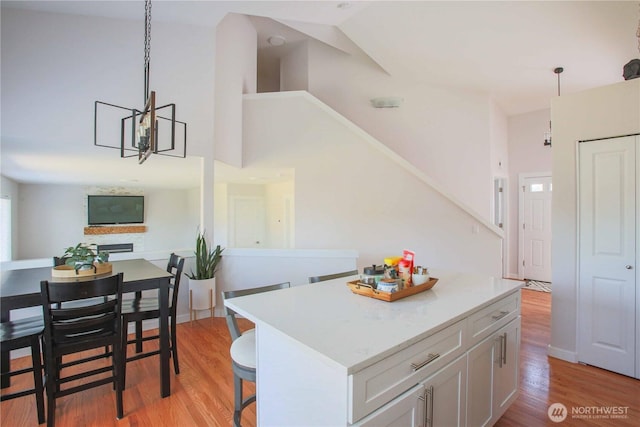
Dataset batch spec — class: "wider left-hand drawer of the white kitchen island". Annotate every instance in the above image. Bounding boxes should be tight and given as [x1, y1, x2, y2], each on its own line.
[348, 320, 466, 423]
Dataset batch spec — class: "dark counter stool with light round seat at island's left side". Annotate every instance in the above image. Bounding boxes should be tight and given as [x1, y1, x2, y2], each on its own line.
[222, 282, 291, 427]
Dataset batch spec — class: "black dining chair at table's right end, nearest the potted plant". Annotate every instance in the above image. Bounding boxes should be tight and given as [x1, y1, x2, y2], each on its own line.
[122, 253, 185, 383]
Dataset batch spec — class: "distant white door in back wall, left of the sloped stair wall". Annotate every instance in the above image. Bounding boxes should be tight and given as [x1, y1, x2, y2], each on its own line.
[229, 196, 266, 248]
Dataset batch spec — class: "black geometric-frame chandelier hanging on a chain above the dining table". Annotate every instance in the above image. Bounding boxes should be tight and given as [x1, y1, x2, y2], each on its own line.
[93, 0, 187, 164]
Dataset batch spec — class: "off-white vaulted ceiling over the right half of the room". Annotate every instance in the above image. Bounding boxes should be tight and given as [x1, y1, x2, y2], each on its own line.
[341, 1, 640, 115]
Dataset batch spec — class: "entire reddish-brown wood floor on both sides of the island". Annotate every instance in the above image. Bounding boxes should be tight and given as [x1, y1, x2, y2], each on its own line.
[0, 290, 640, 427]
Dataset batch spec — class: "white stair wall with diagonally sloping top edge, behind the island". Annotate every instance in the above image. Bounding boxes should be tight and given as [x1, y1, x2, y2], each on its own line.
[244, 92, 501, 276]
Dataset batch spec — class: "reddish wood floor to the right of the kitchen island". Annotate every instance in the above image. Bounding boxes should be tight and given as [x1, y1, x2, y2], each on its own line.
[496, 289, 640, 427]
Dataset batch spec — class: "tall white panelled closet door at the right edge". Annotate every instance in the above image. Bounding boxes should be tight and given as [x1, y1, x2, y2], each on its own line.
[578, 137, 636, 376]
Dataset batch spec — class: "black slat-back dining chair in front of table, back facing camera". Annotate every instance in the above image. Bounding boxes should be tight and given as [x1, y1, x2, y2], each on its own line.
[40, 273, 124, 427]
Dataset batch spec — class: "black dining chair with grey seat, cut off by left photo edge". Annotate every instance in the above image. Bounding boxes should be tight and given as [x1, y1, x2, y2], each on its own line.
[0, 315, 44, 424]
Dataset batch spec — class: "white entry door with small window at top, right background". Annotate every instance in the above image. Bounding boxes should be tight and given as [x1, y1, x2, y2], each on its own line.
[522, 176, 552, 282]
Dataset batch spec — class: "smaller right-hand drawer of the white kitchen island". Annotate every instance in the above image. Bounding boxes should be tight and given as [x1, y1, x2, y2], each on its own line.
[468, 292, 520, 345]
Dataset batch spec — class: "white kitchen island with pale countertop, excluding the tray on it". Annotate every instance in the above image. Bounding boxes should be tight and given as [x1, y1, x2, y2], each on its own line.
[225, 271, 522, 426]
